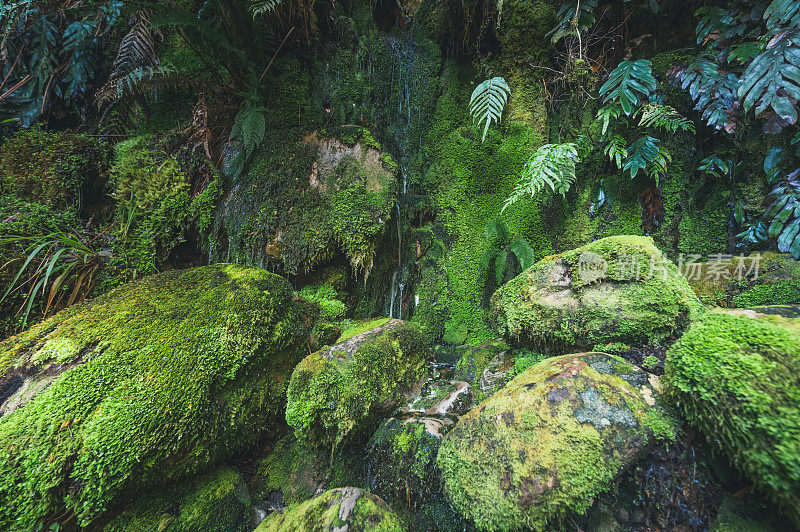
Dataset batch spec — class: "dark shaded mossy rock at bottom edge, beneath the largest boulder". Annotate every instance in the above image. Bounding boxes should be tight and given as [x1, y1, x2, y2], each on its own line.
[104, 467, 255, 532]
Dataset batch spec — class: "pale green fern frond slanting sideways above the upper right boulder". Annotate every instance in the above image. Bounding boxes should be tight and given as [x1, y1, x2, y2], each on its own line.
[501, 142, 579, 212]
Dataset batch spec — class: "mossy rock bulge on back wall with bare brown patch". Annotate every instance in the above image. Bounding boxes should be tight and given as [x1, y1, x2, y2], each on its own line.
[211, 126, 398, 274]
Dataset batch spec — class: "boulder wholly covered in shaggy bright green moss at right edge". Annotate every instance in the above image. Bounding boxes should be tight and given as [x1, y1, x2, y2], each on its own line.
[666, 310, 800, 526]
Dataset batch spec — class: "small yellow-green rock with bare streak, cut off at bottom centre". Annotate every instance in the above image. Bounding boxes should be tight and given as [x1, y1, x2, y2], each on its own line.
[256, 487, 403, 532]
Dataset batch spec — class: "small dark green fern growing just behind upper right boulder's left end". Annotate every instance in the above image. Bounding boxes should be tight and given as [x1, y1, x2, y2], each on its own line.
[479, 218, 536, 286]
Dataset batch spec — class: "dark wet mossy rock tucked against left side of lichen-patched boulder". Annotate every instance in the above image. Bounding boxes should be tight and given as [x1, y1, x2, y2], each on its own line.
[366, 414, 465, 531]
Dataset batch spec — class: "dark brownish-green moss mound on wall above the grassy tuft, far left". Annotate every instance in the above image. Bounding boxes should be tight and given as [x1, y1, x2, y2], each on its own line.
[0, 128, 111, 212]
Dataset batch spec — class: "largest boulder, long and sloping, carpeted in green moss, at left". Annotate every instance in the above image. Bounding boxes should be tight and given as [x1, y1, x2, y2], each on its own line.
[0, 264, 310, 530]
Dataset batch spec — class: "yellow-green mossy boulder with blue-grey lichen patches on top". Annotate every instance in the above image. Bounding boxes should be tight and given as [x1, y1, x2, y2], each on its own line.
[437, 353, 673, 530]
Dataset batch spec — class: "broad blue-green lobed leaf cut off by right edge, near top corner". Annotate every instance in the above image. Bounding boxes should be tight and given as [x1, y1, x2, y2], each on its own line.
[739, 30, 800, 124]
